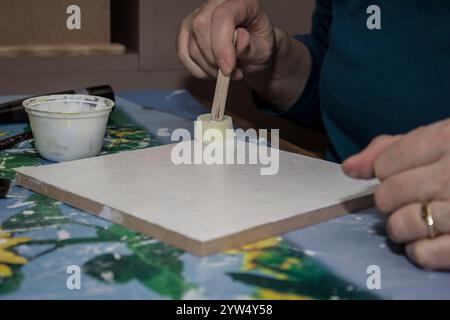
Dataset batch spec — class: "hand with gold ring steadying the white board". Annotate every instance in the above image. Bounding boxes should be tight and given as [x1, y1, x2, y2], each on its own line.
[343, 120, 450, 270]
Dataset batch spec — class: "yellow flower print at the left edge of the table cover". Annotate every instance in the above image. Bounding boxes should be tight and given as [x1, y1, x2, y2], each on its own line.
[0, 229, 31, 277]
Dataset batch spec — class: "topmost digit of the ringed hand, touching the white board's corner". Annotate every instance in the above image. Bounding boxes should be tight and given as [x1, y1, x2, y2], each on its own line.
[342, 136, 401, 179]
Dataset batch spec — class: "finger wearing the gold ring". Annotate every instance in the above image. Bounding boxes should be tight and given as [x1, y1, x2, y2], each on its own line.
[386, 201, 450, 243]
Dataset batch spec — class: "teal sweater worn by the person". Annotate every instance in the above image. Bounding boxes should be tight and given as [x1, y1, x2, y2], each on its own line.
[256, 0, 450, 162]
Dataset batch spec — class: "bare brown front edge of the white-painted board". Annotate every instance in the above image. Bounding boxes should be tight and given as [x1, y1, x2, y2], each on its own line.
[16, 171, 374, 256]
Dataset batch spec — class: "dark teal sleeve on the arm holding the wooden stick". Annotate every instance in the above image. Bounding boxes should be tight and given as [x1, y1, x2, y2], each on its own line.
[253, 0, 333, 130]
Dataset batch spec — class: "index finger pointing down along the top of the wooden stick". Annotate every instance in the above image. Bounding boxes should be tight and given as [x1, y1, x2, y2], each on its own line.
[211, 0, 259, 75]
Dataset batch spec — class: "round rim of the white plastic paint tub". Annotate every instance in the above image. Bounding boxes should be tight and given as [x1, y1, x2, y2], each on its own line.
[22, 94, 115, 115]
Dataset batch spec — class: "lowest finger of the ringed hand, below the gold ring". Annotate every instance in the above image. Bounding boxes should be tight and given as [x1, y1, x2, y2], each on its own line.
[406, 235, 450, 270]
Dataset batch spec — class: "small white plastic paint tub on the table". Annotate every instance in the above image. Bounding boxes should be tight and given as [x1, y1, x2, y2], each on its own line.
[23, 95, 114, 162]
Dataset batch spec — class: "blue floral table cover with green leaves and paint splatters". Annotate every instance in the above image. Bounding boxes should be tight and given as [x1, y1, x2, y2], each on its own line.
[0, 91, 450, 299]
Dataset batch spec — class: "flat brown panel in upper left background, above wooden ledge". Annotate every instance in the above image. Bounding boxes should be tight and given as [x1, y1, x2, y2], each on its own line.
[0, 0, 111, 46]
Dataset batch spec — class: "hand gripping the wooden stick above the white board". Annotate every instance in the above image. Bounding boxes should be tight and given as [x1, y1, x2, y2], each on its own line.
[177, 0, 275, 80]
